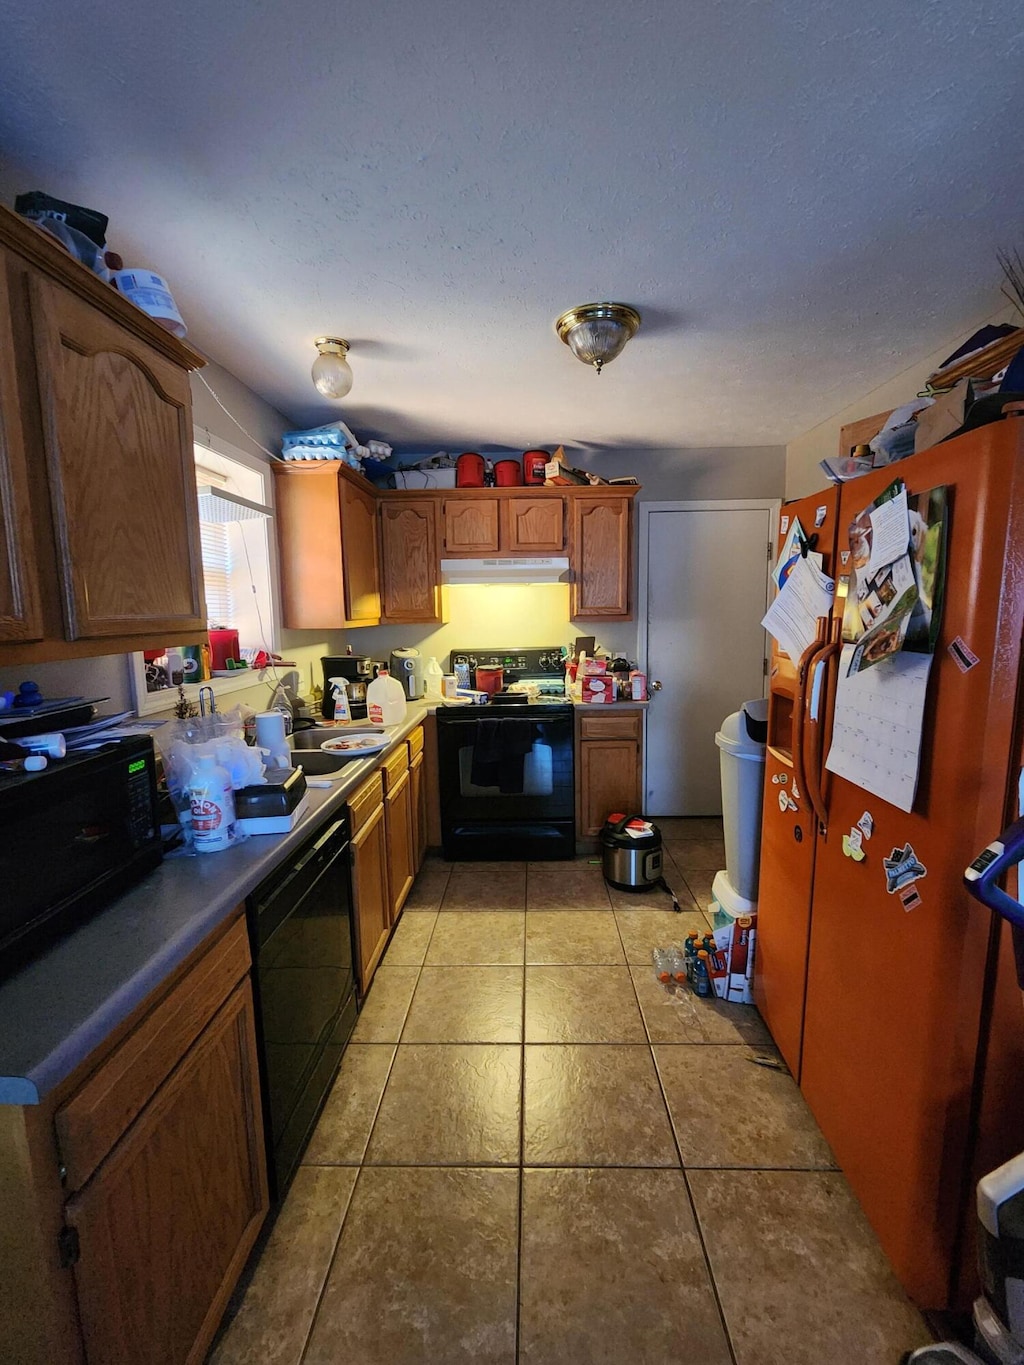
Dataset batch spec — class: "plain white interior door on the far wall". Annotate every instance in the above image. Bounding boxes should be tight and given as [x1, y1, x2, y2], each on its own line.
[640, 500, 778, 818]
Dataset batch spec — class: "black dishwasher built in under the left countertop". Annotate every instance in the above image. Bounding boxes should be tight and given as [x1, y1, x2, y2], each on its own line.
[247, 816, 356, 1200]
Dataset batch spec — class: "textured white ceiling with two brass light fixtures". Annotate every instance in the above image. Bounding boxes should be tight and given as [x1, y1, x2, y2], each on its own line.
[0, 0, 1024, 450]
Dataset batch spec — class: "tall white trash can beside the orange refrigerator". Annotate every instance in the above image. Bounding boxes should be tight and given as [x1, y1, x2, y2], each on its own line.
[714, 698, 767, 902]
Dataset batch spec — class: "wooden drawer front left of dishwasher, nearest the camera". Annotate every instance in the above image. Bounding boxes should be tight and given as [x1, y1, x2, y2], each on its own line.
[55, 915, 251, 1190]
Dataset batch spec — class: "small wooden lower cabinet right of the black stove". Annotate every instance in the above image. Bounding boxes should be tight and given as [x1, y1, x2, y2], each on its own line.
[576, 707, 643, 838]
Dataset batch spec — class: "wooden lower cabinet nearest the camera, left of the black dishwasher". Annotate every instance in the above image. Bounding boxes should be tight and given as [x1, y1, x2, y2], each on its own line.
[0, 910, 269, 1365]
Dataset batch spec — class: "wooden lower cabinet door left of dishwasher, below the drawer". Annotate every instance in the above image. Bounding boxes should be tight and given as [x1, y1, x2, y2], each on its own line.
[66, 979, 268, 1365]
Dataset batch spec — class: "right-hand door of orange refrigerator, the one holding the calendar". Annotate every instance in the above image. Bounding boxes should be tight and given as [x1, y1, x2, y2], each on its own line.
[800, 422, 1024, 1308]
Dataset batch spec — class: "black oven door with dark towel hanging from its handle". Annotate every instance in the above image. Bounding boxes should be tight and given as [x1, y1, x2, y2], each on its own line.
[437, 711, 575, 860]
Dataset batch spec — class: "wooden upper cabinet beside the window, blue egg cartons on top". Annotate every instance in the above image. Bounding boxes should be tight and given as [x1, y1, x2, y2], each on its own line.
[273, 460, 381, 631]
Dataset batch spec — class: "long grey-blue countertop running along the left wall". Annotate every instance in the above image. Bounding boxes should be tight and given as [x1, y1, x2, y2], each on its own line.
[0, 702, 427, 1104]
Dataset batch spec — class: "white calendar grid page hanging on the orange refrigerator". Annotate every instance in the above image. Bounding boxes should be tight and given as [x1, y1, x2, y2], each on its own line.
[825, 644, 933, 811]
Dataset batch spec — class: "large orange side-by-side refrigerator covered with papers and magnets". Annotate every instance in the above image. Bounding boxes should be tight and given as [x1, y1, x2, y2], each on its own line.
[755, 419, 1024, 1308]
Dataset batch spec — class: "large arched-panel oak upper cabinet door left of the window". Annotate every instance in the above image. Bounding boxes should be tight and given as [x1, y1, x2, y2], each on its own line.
[31, 276, 205, 640]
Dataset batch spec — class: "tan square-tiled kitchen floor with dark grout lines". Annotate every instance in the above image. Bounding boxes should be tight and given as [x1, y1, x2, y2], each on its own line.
[212, 820, 931, 1365]
